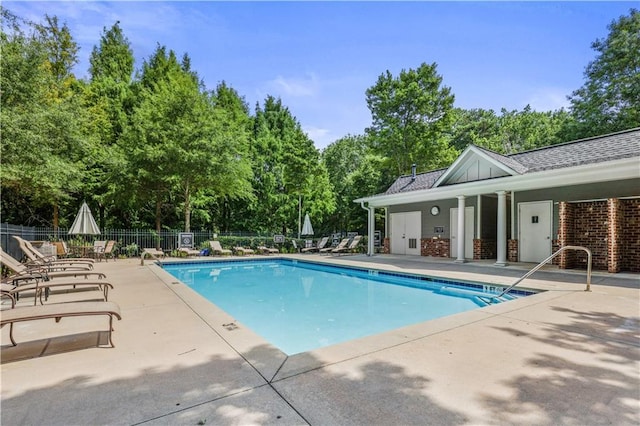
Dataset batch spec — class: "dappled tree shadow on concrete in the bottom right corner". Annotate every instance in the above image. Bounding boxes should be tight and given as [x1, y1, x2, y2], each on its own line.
[484, 307, 640, 425]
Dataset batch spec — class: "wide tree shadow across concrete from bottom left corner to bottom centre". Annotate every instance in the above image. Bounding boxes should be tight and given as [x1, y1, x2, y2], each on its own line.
[1, 339, 464, 425]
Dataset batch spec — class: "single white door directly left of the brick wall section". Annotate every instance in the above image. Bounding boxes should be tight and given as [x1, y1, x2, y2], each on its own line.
[518, 201, 553, 262]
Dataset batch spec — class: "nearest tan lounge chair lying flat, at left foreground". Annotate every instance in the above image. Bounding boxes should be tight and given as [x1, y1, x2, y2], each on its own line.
[0, 296, 122, 348]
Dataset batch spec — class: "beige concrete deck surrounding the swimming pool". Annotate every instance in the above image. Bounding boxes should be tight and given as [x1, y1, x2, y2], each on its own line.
[0, 255, 640, 425]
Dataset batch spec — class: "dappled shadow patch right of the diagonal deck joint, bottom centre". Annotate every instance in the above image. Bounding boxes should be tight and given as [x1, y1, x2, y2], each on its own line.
[273, 348, 466, 426]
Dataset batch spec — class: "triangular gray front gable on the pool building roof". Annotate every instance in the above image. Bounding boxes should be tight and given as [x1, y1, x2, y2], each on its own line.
[433, 145, 526, 187]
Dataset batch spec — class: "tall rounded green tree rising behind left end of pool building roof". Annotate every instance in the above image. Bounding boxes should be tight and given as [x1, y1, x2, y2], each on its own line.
[366, 63, 456, 174]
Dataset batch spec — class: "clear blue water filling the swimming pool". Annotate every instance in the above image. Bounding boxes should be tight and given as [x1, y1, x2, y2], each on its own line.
[163, 259, 522, 355]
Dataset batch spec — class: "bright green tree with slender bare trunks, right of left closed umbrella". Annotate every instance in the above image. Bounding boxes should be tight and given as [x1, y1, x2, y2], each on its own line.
[127, 46, 250, 231]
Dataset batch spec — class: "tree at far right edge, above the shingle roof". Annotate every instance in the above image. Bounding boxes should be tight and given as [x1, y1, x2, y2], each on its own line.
[569, 9, 640, 138]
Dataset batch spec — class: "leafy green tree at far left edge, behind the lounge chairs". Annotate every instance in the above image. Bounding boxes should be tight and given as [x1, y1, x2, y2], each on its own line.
[0, 9, 87, 227]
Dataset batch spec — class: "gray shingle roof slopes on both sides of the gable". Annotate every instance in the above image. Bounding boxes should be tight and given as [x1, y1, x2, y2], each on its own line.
[384, 128, 640, 195]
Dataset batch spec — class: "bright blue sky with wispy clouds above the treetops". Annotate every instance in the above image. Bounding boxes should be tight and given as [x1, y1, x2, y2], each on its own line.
[3, 0, 638, 149]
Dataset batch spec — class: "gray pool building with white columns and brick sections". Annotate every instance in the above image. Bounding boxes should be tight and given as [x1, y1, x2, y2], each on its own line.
[355, 128, 640, 273]
